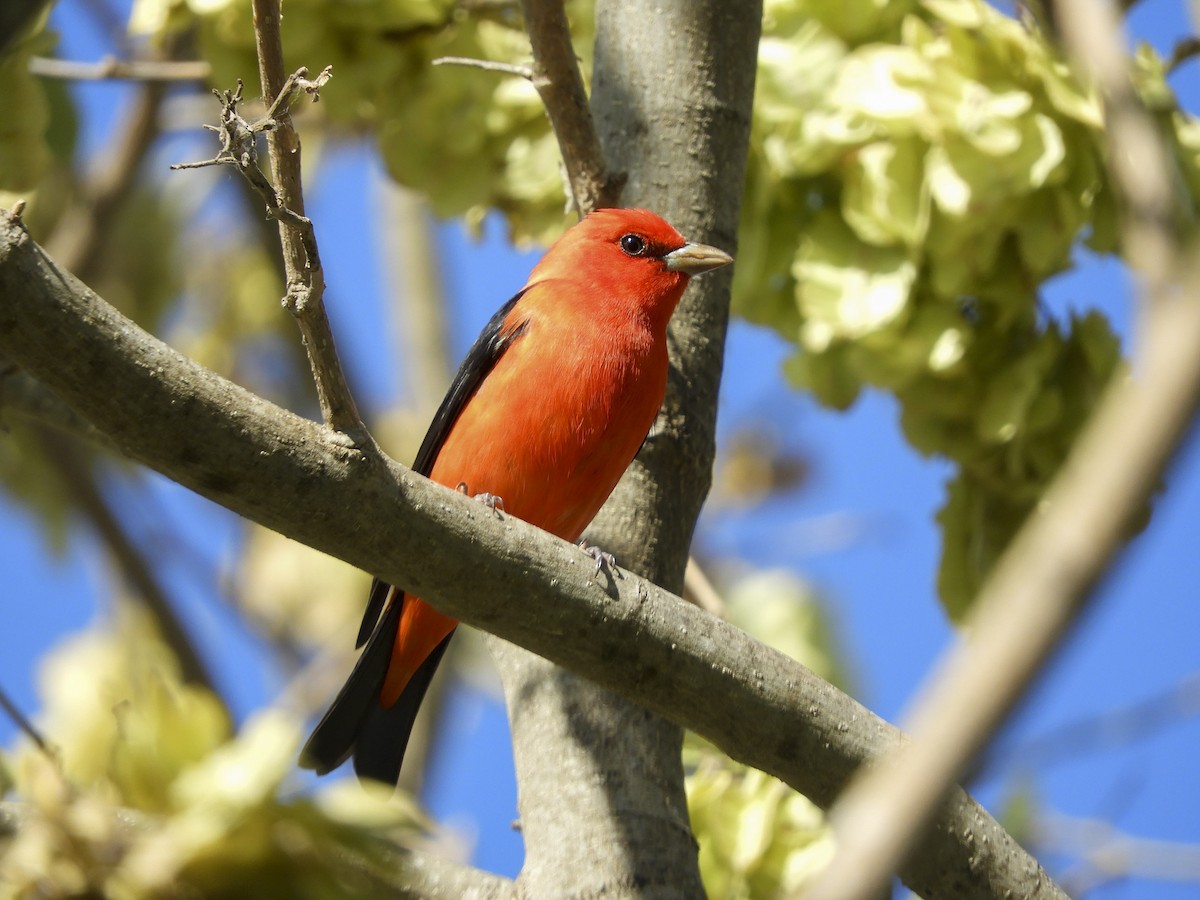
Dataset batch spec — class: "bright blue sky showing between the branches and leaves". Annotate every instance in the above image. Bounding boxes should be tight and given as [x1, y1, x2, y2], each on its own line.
[0, 0, 1200, 900]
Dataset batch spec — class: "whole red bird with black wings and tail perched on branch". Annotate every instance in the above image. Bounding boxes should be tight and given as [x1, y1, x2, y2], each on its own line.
[301, 209, 733, 784]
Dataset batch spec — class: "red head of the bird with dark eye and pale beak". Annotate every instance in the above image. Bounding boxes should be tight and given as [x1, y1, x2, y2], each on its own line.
[529, 209, 733, 324]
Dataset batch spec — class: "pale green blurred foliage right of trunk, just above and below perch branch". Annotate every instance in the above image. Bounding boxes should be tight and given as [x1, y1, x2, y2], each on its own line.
[684, 570, 846, 900]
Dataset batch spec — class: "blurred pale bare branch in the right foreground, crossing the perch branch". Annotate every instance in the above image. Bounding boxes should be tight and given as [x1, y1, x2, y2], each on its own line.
[811, 1, 1200, 900]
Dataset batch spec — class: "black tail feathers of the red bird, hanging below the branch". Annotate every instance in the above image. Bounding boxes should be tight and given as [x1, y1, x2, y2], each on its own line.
[300, 592, 454, 785]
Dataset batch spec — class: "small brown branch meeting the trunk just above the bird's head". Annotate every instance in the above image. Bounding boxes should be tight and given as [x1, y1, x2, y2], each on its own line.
[521, 0, 625, 216]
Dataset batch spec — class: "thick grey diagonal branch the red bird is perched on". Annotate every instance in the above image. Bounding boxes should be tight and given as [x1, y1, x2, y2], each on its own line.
[0, 211, 1065, 898]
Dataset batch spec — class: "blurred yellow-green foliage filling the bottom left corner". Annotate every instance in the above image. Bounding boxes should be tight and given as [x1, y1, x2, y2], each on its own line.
[0, 610, 424, 900]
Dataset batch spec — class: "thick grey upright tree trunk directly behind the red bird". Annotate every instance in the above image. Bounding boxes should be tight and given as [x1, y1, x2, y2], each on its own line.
[493, 0, 762, 898]
